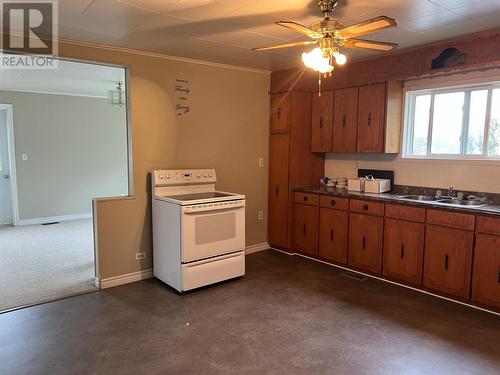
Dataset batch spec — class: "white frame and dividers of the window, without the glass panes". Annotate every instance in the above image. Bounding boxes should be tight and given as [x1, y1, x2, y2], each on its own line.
[402, 81, 500, 161]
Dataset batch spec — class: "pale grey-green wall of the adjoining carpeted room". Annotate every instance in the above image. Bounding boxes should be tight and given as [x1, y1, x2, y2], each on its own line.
[0, 91, 128, 220]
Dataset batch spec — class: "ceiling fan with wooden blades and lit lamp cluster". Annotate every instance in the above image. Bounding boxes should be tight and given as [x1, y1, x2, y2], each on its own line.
[252, 0, 397, 74]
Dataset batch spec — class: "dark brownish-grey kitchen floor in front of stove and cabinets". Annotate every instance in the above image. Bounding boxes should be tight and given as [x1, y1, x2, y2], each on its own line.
[0, 251, 500, 375]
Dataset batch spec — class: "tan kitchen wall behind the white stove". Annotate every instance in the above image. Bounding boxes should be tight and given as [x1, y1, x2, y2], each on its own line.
[59, 43, 270, 278]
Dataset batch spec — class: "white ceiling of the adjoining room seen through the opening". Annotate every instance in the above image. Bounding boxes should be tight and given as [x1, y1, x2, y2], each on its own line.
[0, 56, 125, 98]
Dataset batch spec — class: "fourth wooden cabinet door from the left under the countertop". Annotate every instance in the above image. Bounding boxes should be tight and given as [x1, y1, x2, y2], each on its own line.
[384, 219, 425, 285]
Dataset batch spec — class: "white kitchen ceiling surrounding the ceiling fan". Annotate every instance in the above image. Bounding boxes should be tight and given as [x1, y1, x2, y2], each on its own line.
[47, 0, 500, 70]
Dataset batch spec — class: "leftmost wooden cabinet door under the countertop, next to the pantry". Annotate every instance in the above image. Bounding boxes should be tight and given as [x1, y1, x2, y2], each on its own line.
[293, 204, 319, 255]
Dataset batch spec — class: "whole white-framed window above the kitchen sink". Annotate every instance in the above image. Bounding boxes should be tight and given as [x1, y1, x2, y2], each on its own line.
[403, 84, 500, 159]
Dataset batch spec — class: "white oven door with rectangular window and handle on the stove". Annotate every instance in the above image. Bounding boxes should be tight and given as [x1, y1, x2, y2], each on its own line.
[181, 201, 245, 263]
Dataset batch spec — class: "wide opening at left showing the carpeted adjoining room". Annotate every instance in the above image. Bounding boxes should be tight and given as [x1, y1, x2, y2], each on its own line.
[0, 60, 130, 312]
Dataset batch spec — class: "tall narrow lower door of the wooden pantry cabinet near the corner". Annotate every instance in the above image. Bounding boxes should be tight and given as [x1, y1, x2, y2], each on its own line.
[268, 134, 290, 249]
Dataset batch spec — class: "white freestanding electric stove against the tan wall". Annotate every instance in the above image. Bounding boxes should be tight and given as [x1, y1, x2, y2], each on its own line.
[151, 169, 245, 292]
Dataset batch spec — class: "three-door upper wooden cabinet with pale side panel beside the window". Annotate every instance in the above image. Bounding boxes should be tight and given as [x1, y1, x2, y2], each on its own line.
[311, 81, 403, 153]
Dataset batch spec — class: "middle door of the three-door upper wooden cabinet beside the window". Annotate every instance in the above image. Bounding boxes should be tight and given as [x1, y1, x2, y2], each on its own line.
[332, 87, 358, 152]
